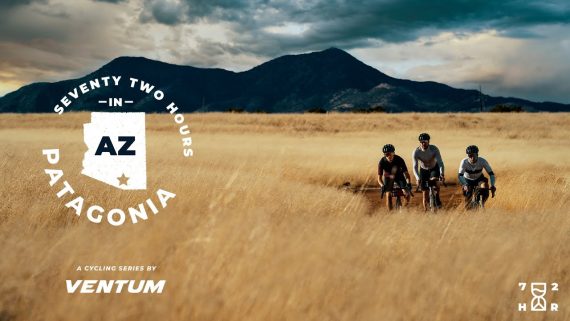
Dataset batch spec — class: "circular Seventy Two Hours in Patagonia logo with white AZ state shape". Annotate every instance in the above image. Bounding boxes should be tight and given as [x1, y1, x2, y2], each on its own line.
[42, 76, 194, 226]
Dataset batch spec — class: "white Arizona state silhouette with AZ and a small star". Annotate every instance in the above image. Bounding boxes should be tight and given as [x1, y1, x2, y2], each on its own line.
[81, 113, 146, 190]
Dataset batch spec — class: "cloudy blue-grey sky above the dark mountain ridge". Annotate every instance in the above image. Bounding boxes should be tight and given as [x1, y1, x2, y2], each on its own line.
[0, 0, 570, 103]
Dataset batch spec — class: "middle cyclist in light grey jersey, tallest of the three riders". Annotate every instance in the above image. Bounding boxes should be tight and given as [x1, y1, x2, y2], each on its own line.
[412, 133, 445, 210]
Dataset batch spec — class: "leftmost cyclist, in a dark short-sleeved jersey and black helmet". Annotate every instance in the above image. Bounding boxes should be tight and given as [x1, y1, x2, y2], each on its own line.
[378, 144, 412, 210]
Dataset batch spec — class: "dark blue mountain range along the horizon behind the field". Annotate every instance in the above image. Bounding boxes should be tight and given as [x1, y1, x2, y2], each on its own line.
[0, 48, 570, 113]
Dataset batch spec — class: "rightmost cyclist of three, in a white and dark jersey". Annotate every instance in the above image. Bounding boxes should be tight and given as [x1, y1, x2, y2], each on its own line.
[459, 145, 497, 205]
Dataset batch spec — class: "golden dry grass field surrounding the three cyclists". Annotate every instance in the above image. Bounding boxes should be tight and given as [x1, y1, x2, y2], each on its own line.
[0, 113, 570, 321]
